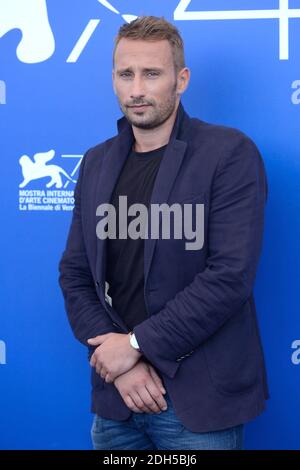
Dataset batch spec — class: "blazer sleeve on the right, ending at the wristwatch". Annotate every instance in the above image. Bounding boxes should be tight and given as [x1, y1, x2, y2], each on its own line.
[134, 134, 267, 377]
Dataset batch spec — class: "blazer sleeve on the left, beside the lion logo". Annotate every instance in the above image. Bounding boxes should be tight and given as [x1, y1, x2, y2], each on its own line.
[59, 152, 117, 350]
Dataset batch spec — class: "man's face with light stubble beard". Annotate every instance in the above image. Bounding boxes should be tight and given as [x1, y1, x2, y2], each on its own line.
[113, 38, 179, 129]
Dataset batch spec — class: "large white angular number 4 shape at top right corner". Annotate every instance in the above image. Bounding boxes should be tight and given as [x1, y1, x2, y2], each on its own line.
[174, 0, 300, 60]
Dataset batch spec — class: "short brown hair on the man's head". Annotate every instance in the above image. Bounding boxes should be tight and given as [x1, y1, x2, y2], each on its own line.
[113, 16, 185, 72]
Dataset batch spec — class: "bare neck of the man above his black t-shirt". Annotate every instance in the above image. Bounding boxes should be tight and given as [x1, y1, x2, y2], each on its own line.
[132, 103, 179, 152]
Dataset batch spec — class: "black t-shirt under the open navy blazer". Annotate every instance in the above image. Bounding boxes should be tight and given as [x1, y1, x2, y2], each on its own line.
[106, 145, 166, 330]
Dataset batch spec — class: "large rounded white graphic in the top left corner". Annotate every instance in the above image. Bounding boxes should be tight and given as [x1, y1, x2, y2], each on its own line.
[0, 0, 55, 64]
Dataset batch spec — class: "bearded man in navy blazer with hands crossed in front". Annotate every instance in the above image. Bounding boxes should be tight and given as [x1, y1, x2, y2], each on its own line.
[60, 13, 268, 449]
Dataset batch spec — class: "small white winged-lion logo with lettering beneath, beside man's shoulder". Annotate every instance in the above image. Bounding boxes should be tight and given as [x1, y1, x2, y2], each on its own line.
[19, 149, 83, 211]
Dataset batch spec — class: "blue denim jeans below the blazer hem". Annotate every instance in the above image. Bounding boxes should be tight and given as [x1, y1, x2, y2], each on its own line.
[91, 395, 243, 450]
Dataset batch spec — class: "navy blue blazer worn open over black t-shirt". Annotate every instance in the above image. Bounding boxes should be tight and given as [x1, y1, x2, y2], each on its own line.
[60, 104, 268, 432]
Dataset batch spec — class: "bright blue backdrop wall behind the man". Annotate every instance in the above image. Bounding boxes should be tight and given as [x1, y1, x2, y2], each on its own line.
[0, 0, 300, 449]
